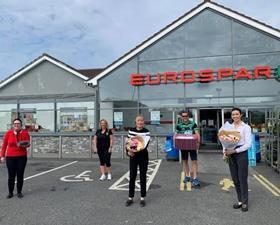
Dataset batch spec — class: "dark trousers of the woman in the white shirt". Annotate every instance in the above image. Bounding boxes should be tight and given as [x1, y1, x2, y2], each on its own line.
[229, 151, 248, 204]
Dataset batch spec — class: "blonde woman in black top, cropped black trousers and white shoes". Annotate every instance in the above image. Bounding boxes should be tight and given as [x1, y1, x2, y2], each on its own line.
[94, 119, 113, 181]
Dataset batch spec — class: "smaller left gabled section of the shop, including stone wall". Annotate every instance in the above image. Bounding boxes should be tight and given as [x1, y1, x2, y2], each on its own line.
[0, 54, 98, 158]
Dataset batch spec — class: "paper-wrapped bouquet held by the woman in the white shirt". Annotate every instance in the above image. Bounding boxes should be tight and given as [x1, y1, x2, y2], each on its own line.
[218, 122, 240, 148]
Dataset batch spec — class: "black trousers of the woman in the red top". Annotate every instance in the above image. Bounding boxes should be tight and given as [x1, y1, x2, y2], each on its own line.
[6, 156, 27, 193]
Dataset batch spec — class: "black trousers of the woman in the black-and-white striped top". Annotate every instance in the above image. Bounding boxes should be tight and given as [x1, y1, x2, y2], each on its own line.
[129, 150, 149, 198]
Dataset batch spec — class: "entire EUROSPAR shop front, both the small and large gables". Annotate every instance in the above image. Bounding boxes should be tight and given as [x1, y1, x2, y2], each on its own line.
[0, 1, 280, 157]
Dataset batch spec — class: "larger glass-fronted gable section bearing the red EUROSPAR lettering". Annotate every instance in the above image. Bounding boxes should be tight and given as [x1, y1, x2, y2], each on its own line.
[88, 1, 280, 148]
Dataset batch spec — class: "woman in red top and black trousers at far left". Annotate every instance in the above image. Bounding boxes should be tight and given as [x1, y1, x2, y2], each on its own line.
[1, 119, 30, 198]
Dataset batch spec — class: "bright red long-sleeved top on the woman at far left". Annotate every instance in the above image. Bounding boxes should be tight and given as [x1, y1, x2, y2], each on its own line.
[1, 130, 30, 157]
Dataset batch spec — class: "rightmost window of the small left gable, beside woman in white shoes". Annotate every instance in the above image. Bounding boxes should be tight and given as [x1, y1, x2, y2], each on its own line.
[57, 102, 94, 132]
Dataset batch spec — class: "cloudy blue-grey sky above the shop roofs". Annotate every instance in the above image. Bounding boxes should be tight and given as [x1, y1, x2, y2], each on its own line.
[0, 0, 280, 80]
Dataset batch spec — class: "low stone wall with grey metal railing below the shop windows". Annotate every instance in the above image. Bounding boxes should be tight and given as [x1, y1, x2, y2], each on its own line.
[0, 132, 170, 159]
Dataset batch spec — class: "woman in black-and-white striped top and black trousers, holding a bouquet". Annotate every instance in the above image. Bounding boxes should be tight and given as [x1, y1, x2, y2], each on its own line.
[126, 116, 150, 207]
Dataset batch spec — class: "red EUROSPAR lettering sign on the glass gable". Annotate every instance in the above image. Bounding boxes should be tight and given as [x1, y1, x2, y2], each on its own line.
[130, 66, 280, 86]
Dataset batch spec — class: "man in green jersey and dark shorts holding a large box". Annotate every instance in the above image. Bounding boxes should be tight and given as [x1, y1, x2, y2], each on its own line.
[176, 111, 200, 186]
